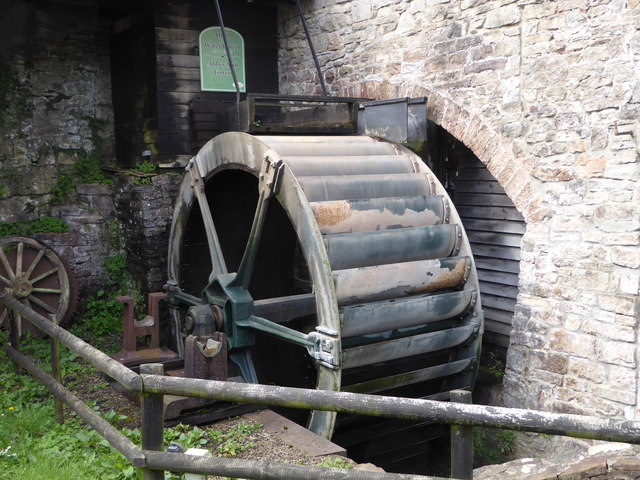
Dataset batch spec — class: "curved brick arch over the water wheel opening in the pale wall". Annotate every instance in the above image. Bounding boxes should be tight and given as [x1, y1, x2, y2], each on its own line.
[358, 82, 548, 223]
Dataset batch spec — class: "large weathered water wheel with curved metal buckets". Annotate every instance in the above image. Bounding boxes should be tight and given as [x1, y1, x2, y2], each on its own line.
[168, 132, 483, 446]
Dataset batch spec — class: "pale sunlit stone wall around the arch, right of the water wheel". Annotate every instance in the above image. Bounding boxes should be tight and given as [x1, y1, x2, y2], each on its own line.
[280, 0, 640, 420]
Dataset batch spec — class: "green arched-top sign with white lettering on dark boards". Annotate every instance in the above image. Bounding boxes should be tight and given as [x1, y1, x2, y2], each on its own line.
[200, 27, 247, 92]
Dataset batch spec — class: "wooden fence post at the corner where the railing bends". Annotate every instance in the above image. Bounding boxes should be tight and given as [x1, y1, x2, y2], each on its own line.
[140, 363, 164, 480]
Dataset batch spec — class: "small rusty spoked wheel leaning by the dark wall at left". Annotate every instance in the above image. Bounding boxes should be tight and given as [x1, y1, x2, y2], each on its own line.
[0, 236, 77, 334]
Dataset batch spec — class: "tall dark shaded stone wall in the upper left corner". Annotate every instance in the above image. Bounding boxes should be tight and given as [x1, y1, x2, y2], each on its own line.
[0, 0, 114, 222]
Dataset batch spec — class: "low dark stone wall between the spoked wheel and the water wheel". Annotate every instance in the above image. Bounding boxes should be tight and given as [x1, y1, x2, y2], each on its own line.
[34, 174, 182, 304]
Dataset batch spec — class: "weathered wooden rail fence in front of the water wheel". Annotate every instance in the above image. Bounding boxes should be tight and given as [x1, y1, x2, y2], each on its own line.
[0, 293, 640, 480]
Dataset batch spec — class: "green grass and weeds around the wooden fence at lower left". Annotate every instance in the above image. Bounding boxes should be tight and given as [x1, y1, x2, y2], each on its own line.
[0, 331, 262, 480]
